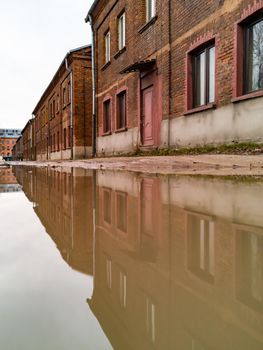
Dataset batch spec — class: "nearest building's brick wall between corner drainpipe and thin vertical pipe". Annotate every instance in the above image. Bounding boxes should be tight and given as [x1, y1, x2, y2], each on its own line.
[94, 0, 169, 135]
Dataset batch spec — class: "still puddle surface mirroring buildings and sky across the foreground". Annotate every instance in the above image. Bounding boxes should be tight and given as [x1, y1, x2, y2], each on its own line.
[0, 167, 263, 350]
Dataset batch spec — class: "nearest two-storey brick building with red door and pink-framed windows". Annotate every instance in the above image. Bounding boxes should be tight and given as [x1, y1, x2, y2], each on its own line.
[86, 0, 263, 154]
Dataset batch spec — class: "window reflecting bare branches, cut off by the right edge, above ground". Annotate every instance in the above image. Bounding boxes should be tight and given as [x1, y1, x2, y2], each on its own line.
[245, 16, 263, 93]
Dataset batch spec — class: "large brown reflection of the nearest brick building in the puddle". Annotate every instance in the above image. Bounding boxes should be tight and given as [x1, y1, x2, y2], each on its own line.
[89, 173, 263, 350]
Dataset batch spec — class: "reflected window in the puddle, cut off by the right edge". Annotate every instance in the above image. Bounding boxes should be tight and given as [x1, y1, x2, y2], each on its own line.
[236, 231, 263, 312]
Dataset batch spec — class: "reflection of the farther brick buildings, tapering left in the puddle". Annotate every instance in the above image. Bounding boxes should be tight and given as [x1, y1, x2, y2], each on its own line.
[14, 167, 93, 275]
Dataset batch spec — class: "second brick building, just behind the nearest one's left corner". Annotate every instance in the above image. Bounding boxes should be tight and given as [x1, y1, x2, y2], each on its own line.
[32, 46, 92, 160]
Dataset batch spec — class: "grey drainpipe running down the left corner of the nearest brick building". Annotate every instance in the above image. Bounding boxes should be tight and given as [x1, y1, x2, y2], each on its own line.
[86, 15, 97, 157]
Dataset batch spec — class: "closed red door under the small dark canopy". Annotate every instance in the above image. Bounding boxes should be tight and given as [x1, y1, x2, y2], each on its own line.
[142, 86, 154, 146]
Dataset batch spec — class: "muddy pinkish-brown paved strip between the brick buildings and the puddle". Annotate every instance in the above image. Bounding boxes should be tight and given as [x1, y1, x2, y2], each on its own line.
[10, 154, 263, 176]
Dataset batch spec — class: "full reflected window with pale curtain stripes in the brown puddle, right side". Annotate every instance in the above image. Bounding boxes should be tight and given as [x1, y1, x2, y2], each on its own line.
[187, 215, 215, 283]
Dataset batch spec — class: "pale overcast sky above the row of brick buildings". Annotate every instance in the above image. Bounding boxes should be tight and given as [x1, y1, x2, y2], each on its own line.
[0, 0, 93, 128]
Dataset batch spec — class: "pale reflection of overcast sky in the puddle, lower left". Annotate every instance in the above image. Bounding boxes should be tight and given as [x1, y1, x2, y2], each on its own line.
[0, 193, 111, 350]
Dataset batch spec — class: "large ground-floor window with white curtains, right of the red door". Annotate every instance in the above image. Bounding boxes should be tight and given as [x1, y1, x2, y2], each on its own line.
[192, 44, 215, 108]
